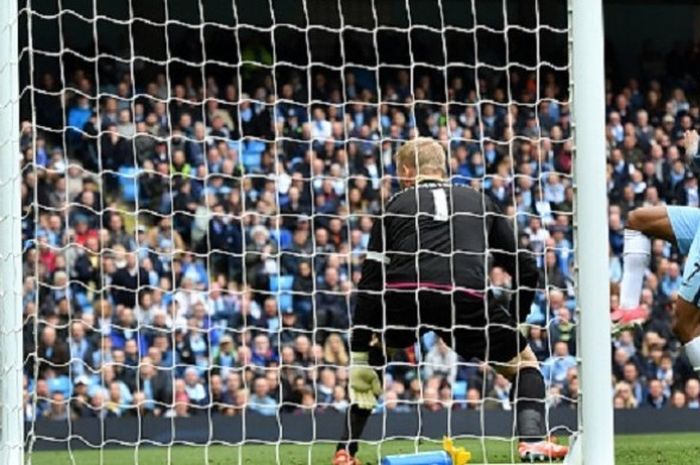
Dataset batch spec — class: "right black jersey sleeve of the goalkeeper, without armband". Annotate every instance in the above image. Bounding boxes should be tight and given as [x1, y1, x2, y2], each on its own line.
[488, 206, 539, 321]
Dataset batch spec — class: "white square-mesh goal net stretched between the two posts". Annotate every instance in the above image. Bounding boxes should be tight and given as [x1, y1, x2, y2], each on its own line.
[17, 0, 579, 464]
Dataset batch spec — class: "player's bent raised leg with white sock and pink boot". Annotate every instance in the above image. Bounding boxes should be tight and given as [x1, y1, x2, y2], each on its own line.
[612, 207, 700, 326]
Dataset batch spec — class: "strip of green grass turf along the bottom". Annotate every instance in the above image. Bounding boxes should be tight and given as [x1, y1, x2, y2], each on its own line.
[27, 434, 700, 465]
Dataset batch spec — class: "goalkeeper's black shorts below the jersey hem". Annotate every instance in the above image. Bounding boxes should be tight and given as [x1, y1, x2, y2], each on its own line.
[383, 290, 527, 363]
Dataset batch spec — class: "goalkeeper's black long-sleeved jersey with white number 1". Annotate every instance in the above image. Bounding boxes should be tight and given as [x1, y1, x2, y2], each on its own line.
[352, 182, 538, 351]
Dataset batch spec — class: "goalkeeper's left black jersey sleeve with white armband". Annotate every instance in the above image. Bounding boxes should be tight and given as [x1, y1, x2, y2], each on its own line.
[351, 218, 388, 352]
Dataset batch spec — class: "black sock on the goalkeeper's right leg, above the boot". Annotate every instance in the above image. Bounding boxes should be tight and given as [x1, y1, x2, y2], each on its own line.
[511, 367, 547, 442]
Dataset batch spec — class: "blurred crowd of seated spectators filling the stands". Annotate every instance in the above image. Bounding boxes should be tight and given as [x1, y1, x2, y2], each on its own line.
[21, 40, 700, 421]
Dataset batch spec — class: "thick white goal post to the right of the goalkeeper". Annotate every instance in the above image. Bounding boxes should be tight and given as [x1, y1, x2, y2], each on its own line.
[569, 0, 615, 465]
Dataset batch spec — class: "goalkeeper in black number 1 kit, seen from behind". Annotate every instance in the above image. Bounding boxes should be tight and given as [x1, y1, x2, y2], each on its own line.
[333, 138, 567, 465]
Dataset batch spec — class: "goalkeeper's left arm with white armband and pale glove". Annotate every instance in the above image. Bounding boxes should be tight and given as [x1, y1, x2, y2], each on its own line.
[349, 219, 388, 410]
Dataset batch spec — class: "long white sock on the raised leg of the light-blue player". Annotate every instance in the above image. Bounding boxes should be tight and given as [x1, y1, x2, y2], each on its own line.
[620, 229, 651, 309]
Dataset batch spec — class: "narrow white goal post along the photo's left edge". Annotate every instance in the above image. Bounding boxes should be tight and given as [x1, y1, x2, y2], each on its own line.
[0, 1, 24, 465]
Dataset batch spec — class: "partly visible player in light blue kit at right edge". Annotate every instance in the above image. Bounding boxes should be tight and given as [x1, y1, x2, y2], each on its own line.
[611, 130, 700, 371]
